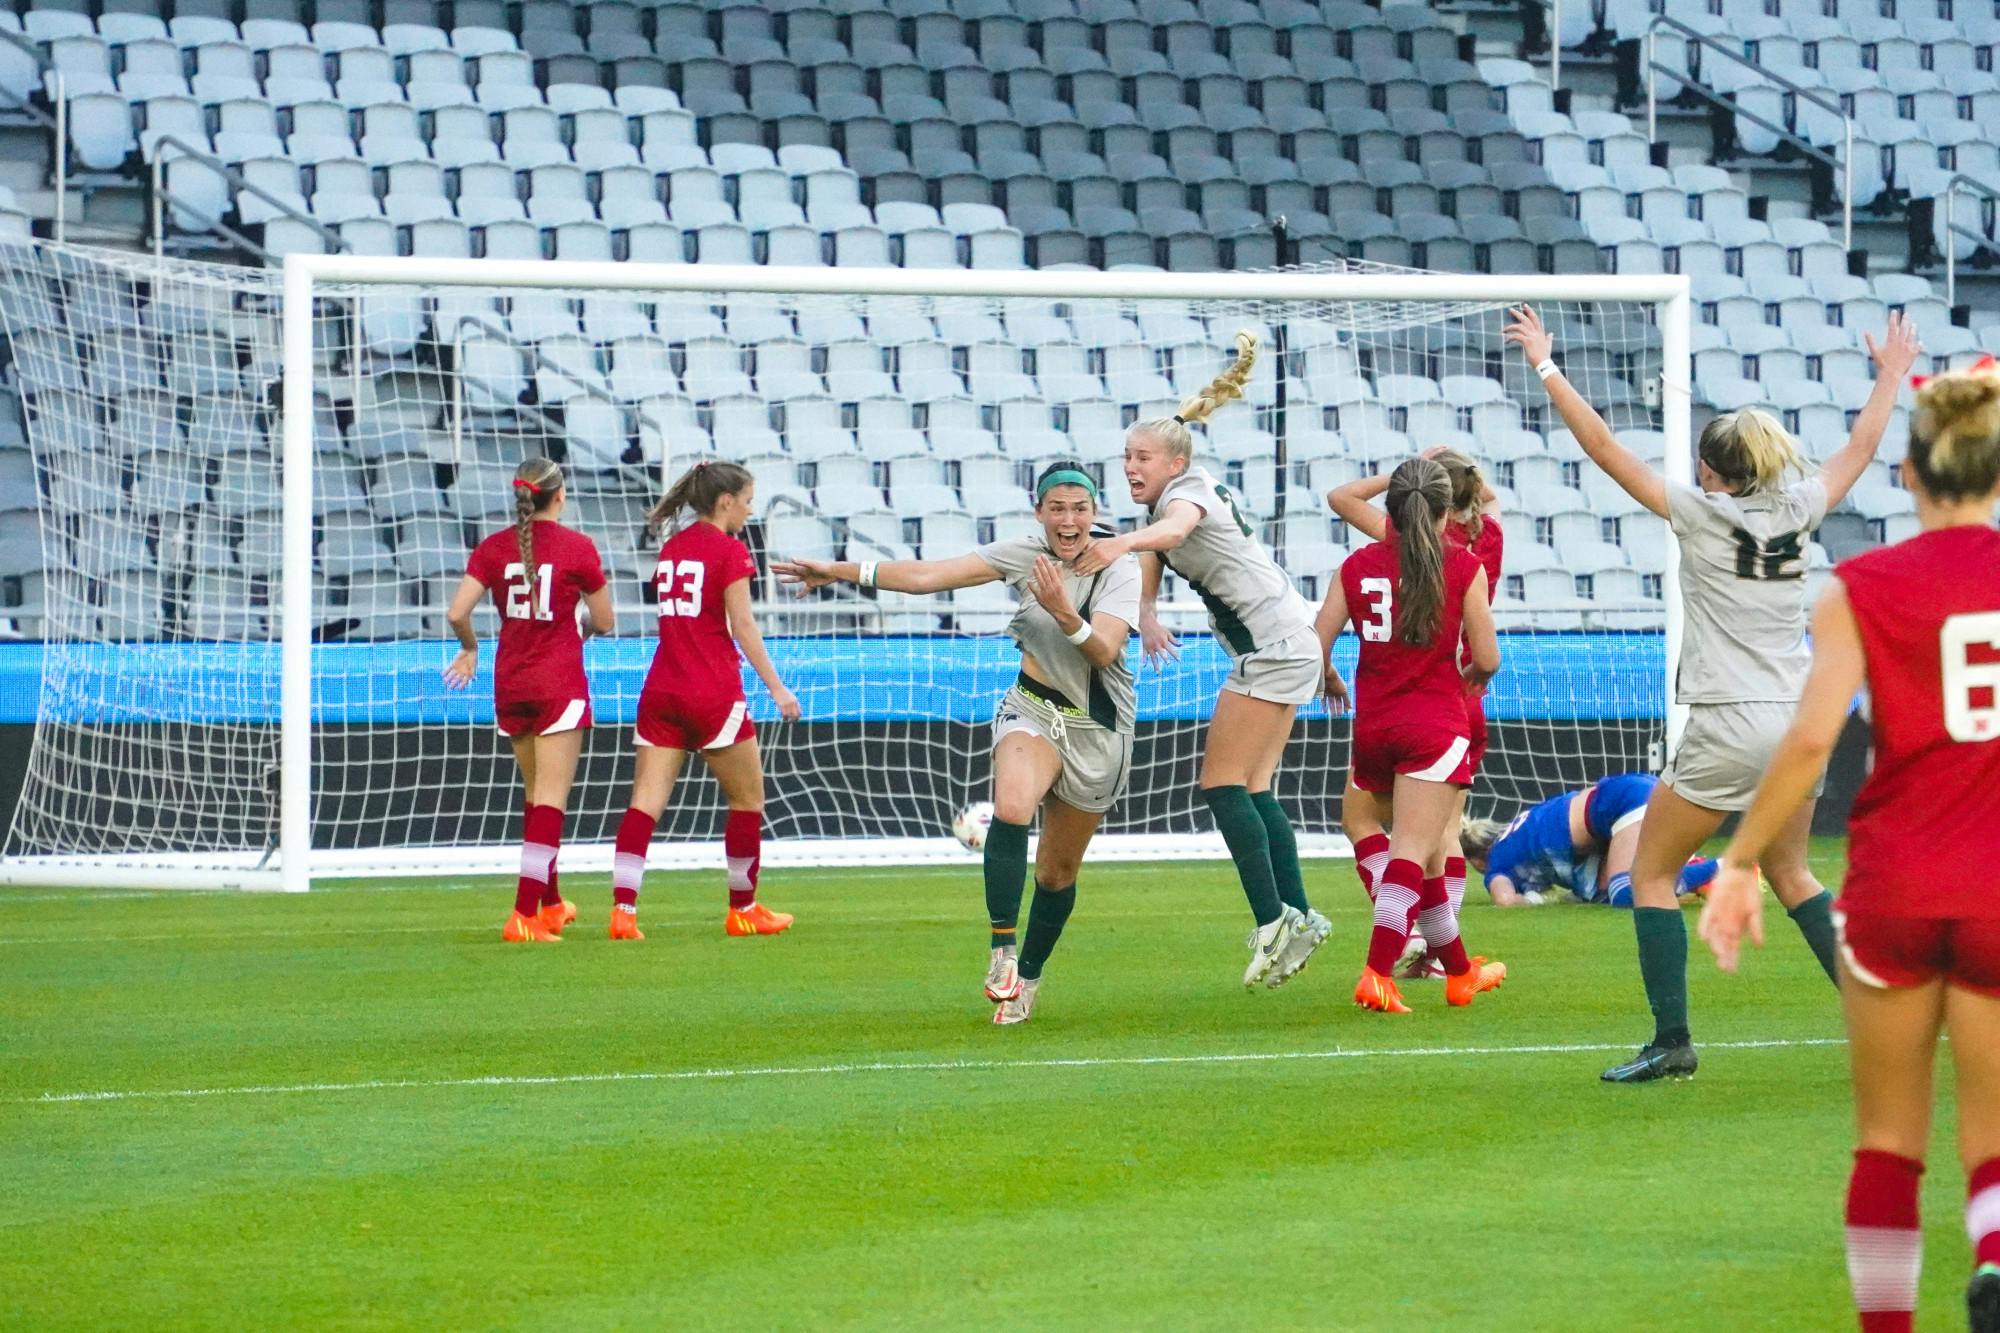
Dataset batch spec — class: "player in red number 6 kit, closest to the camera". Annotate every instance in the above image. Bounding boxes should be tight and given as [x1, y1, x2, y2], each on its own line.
[1702, 356, 2000, 1333]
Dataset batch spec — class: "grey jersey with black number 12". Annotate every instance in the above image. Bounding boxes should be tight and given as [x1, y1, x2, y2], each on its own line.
[1666, 476, 1826, 705]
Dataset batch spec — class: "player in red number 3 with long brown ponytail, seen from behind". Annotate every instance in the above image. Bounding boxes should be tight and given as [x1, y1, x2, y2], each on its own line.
[1314, 458, 1506, 1013]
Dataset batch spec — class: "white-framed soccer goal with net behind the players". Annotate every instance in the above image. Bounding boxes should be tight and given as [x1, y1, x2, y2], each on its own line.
[0, 242, 1690, 889]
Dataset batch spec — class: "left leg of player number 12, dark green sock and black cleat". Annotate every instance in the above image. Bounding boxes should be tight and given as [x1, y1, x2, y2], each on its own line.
[1602, 783, 1724, 1083]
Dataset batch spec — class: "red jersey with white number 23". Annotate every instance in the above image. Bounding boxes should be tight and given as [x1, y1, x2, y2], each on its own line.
[644, 522, 756, 699]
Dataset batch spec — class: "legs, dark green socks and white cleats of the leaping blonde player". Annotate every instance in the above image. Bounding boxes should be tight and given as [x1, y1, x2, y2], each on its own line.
[1202, 691, 1324, 987]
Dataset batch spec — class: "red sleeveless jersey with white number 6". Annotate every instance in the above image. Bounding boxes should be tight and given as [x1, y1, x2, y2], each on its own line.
[1834, 526, 2000, 917]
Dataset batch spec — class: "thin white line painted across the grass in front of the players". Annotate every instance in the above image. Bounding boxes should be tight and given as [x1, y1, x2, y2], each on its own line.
[19, 1037, 1846, 1107]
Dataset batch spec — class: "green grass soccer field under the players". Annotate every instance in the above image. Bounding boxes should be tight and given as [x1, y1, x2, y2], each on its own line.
[0, 843, 1968, 1331]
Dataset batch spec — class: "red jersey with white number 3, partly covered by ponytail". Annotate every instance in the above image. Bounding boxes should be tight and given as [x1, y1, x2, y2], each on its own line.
[1340, 540, 1480, 720]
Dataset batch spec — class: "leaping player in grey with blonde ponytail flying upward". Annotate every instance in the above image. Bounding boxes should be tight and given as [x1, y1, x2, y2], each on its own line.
[1076, 332, 1332, 987]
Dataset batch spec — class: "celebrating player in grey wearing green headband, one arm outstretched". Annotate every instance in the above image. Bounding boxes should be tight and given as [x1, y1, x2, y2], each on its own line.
[772, 462, 1140, 1025]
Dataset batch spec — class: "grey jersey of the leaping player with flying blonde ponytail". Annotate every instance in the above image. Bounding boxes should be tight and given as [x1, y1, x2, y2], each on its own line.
[1146, 468, 1312, 656]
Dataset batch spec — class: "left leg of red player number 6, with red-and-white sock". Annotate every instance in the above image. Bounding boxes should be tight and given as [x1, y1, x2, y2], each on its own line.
[1840, 975, 1958, 1327]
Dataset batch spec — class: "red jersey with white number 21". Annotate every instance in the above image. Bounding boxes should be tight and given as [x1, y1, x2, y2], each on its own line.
[466, 520, 604, 705]
